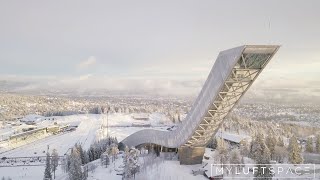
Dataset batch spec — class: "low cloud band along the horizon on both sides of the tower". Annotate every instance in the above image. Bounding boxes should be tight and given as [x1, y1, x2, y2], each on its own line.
[0, 73, 320, 99]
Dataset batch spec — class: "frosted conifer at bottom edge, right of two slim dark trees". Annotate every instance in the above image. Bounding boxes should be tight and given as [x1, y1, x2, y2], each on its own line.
[68, 148, 83, 180]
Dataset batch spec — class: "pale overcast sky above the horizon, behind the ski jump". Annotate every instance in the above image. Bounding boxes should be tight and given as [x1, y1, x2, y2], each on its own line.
[0, 0, 320, 96]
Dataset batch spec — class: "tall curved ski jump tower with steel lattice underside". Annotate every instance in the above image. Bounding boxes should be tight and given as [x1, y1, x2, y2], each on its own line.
[122, 45, 280, 164]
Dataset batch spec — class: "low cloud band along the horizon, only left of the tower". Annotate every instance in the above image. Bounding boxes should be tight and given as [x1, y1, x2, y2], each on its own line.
[0, 74, 204, 96]
